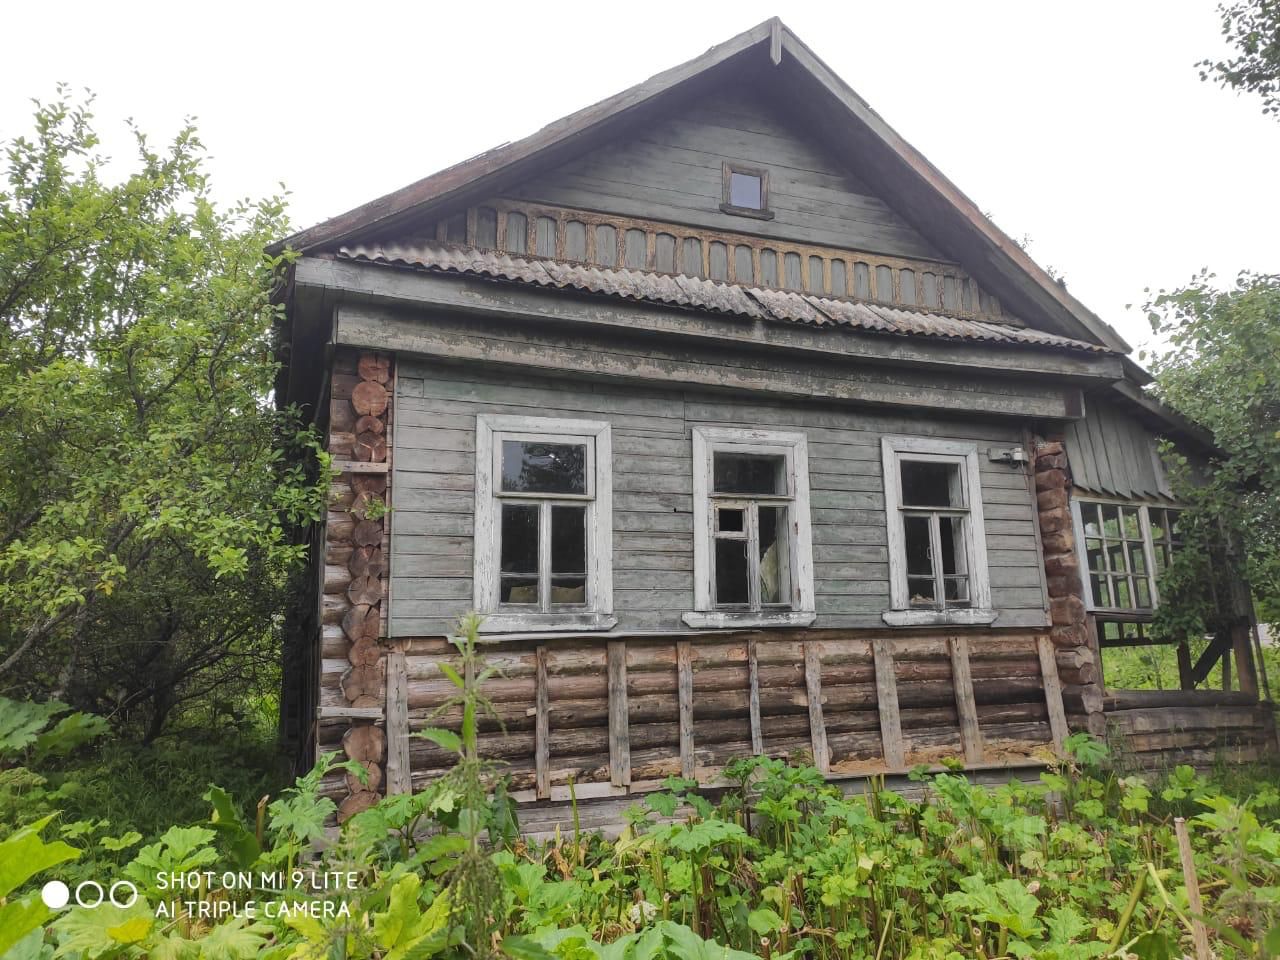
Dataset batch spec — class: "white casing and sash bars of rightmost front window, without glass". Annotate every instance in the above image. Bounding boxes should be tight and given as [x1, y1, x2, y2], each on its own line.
[881, 436, 996, 626]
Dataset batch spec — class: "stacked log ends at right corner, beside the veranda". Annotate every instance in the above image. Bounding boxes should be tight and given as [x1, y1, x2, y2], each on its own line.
[1034, 436, 1106, 736]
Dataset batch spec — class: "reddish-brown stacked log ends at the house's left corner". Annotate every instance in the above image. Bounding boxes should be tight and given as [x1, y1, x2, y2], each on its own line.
[324, 352, 393, 823]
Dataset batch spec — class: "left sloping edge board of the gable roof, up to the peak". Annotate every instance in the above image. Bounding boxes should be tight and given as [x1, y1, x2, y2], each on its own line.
[268, 17, 781, 253]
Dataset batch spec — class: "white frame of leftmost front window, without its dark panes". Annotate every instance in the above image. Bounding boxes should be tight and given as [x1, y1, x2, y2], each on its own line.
[472, 413, 618, 634]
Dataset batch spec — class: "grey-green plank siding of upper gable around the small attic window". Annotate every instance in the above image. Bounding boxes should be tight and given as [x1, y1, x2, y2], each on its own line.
[508, 83, 942, 260]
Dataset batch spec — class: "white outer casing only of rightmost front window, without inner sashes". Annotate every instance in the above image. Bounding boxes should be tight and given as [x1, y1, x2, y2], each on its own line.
[881, 436, 998, 626]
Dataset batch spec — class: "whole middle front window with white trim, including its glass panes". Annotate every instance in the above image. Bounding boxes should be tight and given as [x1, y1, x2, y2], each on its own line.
[684, 426, 815, 627]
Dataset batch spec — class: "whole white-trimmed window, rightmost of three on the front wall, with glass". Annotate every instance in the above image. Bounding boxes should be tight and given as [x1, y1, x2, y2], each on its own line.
[881, 436, 996, 625]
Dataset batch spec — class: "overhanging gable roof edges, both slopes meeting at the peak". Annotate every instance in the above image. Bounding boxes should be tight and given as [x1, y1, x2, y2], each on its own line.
[273, 18, 1130, 353]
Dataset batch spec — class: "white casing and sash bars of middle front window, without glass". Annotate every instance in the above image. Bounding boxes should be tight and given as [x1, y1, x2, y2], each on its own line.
[682, 426, 817, 628]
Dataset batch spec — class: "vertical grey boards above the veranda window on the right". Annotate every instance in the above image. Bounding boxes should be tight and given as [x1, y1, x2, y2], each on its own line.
[1066, 397, 1174, 498]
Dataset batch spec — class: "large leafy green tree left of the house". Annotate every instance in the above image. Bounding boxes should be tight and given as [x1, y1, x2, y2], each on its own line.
[0, 88, 324, 736]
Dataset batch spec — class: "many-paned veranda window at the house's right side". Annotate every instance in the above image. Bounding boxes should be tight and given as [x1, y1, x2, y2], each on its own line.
[1071, 499, 1181, 616]
